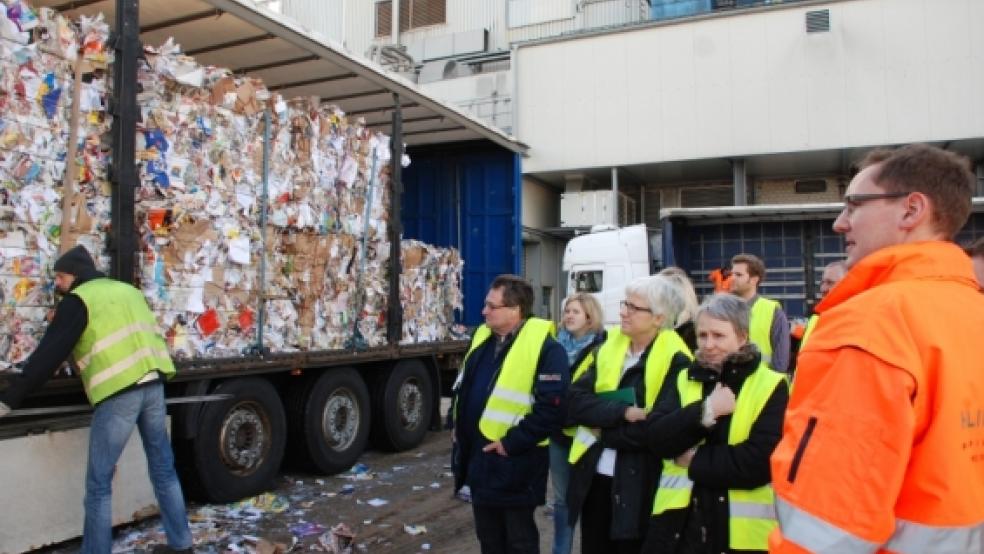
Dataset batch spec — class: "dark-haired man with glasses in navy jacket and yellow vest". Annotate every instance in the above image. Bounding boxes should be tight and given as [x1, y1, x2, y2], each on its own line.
[451, 275, 570, 554]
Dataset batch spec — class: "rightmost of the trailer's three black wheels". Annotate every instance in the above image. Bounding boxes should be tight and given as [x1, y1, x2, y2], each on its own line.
[372, 360, 434, 452]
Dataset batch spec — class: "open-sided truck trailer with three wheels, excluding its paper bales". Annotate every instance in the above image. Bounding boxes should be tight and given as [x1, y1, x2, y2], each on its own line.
[0, 0, 526, 552]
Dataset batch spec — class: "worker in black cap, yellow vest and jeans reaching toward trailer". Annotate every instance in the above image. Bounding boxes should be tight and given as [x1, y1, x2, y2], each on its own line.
[0, 246, 192, 554]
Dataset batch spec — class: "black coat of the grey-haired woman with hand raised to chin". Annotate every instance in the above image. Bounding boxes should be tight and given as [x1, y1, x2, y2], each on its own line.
[643, 345, 789, 554]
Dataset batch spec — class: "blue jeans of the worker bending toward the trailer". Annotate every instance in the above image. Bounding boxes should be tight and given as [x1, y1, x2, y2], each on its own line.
[82, 383, 192, 554]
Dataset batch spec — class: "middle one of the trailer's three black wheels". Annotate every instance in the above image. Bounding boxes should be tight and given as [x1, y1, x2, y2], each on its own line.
[288, 367, 370, 475]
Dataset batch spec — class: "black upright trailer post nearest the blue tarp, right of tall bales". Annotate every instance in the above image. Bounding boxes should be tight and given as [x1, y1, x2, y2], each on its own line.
[386, 92, 403, 346]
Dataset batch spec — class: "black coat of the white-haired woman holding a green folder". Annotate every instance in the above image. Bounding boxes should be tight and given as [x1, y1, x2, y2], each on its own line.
[567, 336, 690, 540]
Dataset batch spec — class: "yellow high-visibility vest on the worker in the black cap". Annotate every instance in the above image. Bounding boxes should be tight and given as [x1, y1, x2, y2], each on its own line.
[72, 278, 175, 404]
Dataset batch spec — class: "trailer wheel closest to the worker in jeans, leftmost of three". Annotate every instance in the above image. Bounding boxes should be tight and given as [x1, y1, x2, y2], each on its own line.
[192, 378, 287, 502]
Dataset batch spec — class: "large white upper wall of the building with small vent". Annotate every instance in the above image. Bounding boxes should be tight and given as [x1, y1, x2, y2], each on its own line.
[514, 0, 984, 172]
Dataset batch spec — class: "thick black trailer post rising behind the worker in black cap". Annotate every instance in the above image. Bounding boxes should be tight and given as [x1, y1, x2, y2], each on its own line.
[109, 0, 142, 283]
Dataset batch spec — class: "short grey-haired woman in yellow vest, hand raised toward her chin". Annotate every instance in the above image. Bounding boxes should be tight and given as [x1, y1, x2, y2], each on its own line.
[643, 294, 788, 554]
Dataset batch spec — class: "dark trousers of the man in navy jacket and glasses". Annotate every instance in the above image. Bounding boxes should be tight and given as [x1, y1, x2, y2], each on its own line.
[472, 504, 540, 554]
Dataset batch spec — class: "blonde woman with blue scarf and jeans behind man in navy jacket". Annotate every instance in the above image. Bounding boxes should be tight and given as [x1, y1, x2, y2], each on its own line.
[550, 292, 605, 554]
